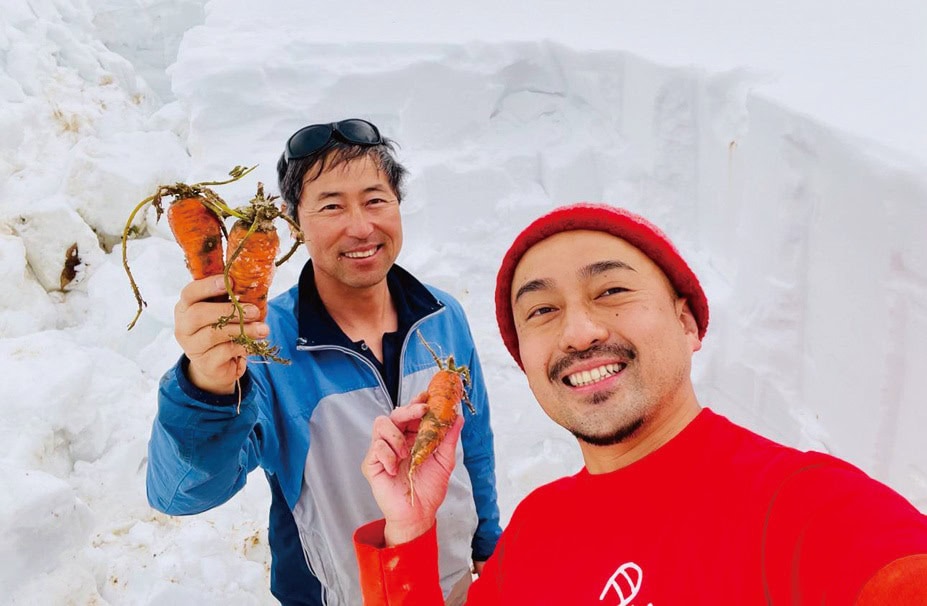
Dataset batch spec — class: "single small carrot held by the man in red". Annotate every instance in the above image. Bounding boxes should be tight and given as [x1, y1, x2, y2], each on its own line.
[409, 332, 476, 505]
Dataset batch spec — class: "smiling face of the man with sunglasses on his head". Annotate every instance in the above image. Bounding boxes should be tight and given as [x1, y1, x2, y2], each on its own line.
[297, 156, 402, 293]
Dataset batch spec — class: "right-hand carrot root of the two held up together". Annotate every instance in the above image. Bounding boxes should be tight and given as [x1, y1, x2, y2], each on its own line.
[227, 220, 280, 320]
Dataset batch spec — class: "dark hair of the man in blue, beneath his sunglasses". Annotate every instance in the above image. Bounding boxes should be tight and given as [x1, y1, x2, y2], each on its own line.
[277, 138, 408, 221]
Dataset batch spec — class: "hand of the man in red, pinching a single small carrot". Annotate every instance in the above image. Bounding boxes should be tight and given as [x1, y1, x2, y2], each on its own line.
[361, 393, 463, 545]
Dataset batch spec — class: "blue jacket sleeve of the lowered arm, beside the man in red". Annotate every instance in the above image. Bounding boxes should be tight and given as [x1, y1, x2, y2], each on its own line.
[461, 329, 502, 561]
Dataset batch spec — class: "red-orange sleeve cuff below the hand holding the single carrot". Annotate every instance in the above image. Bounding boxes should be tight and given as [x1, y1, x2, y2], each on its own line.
[354, 520, 444, 606]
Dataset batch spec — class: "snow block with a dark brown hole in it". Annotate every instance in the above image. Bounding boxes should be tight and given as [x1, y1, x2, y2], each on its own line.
[11, 196, 103, 292]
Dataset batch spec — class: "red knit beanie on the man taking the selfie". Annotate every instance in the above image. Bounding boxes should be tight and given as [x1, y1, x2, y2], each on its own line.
[496, 202, 708, 370]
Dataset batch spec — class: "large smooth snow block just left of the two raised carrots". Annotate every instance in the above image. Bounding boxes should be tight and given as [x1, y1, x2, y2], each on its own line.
[65, 131, 189, 242]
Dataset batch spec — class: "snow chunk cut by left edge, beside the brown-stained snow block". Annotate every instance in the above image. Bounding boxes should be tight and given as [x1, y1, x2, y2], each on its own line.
[0, 233, 55, 337]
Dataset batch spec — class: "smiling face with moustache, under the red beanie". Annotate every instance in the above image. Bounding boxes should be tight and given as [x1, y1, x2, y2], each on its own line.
[512, 231, 701, 446]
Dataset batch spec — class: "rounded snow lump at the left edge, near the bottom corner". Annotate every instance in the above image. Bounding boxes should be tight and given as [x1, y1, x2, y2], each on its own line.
[0, 468, 93, 595]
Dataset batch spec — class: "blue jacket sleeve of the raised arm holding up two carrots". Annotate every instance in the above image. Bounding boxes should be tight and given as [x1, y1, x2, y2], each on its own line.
[146, 357, 269, 515]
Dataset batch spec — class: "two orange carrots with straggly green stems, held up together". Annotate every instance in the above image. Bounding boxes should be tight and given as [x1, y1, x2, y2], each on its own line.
[122, 166, 302, 364]
